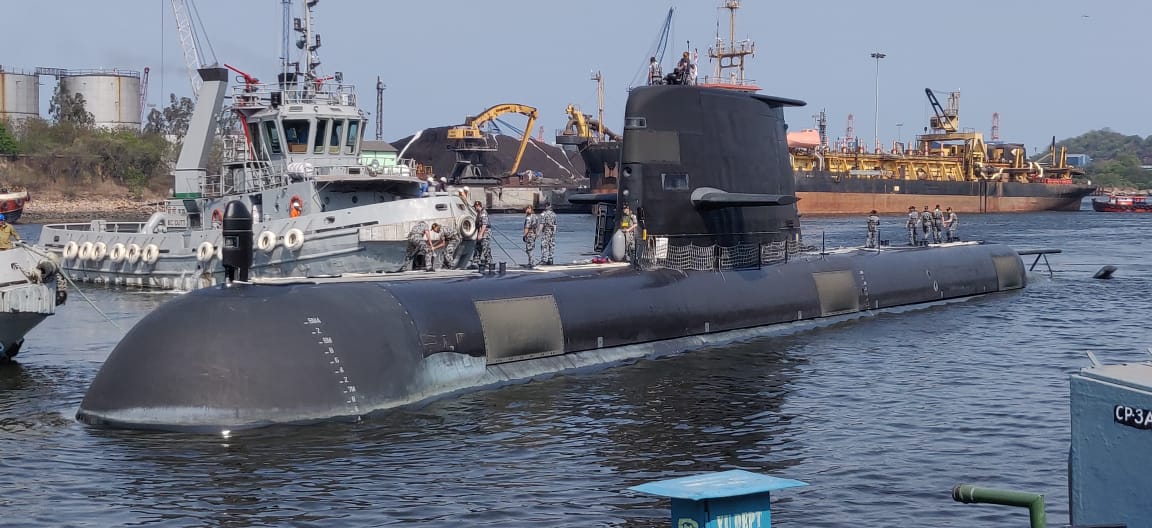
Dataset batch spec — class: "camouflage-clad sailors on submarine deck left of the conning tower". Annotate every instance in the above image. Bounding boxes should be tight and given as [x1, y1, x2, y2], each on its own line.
[400, 201, 556, 271]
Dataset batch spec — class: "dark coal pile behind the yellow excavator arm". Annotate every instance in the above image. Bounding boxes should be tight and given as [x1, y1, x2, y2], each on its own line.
[391, 127, 586, 184]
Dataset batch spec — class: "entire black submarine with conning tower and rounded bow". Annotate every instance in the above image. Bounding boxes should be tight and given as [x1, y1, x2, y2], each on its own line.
[76, 85, 1026, 432]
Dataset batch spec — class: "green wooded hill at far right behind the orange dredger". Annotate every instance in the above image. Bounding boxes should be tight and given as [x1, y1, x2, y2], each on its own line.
[1056, 128, 1152, 190]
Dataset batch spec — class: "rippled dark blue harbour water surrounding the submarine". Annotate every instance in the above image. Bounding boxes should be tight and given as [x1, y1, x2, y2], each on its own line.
[0, 204, 1152, 527]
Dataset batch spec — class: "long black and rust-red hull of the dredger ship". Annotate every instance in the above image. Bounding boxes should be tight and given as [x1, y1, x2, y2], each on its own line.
[795, 171, 1096, 214]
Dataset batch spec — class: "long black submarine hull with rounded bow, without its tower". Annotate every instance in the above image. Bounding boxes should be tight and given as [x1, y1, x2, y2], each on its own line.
[77, 243, 1025, 431]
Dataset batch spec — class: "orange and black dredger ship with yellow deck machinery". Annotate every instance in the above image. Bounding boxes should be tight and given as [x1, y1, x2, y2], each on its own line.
[788, 89, 1096, 214]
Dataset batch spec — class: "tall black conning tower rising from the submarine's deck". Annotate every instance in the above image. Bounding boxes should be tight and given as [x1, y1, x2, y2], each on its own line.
[617, 85, 804, 269]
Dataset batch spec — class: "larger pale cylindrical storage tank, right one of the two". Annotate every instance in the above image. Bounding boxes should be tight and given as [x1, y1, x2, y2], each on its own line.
[60, 69, 141, 128]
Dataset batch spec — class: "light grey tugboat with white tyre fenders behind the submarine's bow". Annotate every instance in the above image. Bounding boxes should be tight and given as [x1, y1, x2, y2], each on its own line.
[39, 1, 476, 291]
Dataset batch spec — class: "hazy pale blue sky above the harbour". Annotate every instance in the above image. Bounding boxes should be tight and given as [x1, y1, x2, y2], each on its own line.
[0, 0, 1152, 150]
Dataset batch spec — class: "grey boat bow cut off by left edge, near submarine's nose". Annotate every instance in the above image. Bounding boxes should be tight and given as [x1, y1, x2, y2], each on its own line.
[0, 244, 68, 363]
